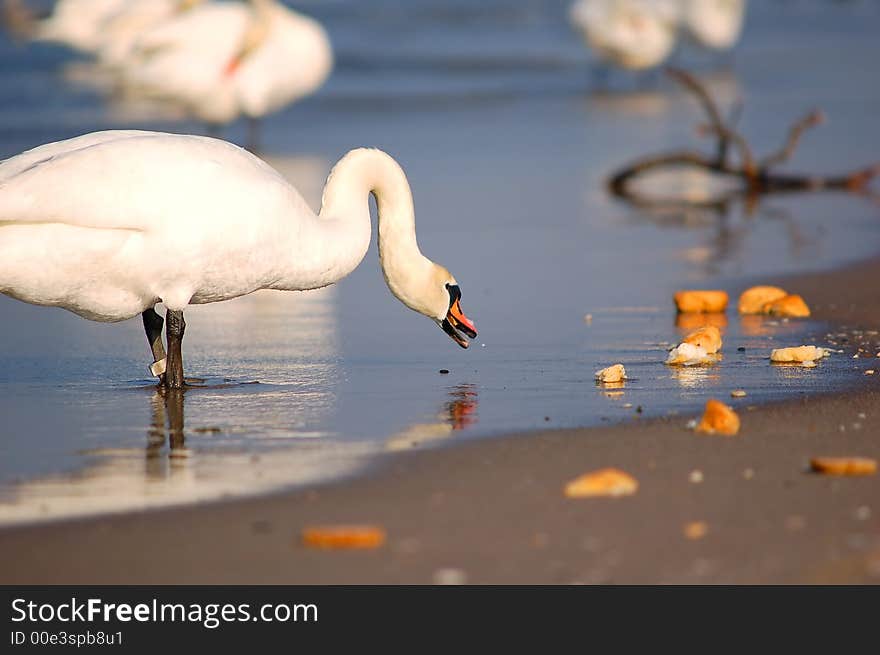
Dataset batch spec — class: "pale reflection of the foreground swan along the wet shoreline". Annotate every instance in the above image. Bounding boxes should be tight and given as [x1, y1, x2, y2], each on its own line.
[0, 376, 478, 524]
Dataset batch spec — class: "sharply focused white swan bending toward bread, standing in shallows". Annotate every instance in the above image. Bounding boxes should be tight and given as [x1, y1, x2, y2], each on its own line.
[0, 131, 477, 387]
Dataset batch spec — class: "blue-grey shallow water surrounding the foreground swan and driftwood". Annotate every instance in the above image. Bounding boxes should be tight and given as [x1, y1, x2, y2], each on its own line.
[0, 1, 880, 522]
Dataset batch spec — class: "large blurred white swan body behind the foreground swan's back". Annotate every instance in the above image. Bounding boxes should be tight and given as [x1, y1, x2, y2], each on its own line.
[125, 0, 333, 124]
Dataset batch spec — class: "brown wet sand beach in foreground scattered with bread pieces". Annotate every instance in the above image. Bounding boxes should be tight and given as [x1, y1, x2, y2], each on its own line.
[0, 259, 880, 584]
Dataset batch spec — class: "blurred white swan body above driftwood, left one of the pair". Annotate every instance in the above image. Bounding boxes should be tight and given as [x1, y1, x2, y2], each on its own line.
[569, 0, 678, 70]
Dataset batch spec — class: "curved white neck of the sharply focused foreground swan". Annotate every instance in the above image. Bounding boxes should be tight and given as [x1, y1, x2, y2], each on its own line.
[320, 148, 434, 311]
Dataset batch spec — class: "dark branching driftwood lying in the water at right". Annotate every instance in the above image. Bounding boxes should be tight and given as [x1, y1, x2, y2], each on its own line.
[608, 69, 880, 207]
